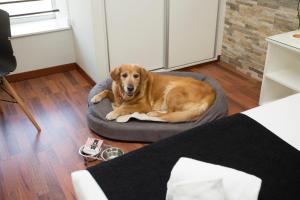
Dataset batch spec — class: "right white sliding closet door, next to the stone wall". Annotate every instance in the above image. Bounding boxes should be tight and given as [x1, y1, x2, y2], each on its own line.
[168, 0, 218, 67]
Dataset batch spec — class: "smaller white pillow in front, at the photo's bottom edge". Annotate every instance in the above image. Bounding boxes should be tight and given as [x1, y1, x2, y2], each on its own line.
[166, 179, 224, 200]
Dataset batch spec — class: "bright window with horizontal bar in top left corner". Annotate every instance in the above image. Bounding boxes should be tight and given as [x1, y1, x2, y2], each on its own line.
[0, 0, 59, 24]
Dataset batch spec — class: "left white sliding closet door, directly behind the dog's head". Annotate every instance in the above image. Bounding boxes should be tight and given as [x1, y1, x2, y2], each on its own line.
[105, 0, 165, 70]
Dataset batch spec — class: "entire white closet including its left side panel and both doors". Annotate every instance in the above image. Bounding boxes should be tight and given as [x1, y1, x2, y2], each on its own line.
[68, 0, 221, 81]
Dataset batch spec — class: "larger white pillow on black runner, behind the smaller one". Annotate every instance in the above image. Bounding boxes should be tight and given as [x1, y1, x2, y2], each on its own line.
[167, 158, 261, 200]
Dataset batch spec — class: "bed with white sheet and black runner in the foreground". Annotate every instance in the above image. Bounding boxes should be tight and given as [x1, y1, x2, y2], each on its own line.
[72, 94, 300, 200]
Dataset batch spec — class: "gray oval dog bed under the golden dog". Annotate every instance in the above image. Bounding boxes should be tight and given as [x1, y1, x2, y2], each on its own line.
[87, 72, 228, 142]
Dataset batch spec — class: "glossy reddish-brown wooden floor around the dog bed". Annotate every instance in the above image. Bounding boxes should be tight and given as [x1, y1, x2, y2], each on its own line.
[0, 63, 260, 200]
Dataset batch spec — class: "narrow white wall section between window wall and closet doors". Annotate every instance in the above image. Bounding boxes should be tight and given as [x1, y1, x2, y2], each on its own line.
[68, 0, 108, 82]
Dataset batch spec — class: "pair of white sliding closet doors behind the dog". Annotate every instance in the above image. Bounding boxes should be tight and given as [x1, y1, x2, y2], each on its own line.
[105, 0, 219, 70]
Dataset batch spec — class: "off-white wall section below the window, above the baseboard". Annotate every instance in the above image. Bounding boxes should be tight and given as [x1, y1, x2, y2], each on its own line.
[12, 30, 75, 73]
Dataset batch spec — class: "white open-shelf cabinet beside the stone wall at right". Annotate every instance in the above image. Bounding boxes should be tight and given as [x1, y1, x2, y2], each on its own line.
[259, 31, 300, 105]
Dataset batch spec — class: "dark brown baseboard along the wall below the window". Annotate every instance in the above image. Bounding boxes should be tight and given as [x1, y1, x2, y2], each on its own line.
[6, 63, 77, 82]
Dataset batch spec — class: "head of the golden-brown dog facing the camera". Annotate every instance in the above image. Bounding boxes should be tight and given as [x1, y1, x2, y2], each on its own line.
[110, 64, 148, 100]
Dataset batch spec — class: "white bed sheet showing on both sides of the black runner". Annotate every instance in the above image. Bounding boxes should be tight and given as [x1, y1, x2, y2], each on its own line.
[72, 93, 300, 200]
